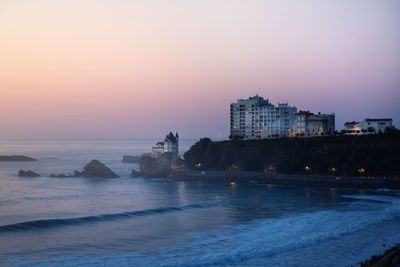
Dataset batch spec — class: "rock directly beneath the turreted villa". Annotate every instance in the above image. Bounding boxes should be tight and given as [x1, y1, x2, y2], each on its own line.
[140, 152, 173, 177]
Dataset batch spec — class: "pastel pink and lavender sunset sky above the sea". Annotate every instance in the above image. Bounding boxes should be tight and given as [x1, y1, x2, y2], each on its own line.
[0, 0, 400, 139]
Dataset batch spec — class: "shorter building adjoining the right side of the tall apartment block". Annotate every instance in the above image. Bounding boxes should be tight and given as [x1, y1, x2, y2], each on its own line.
[291, 111, 335, 137]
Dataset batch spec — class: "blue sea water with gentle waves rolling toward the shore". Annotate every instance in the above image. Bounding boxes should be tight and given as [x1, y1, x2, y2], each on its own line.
[0, 140, 400, 266]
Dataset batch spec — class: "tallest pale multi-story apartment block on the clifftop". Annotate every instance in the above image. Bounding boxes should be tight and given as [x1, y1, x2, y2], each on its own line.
[230, 95, 297, 139]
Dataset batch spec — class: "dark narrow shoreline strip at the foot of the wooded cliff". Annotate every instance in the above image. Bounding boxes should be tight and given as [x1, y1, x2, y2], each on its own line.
[170, 170, 400, 189]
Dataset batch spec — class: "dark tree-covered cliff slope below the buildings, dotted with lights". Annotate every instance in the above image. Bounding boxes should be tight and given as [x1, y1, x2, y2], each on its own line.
[184, 130, 400, 176]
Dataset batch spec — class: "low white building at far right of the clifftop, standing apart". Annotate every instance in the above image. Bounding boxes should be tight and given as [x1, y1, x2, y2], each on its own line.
[344, 118, 393, 135]
